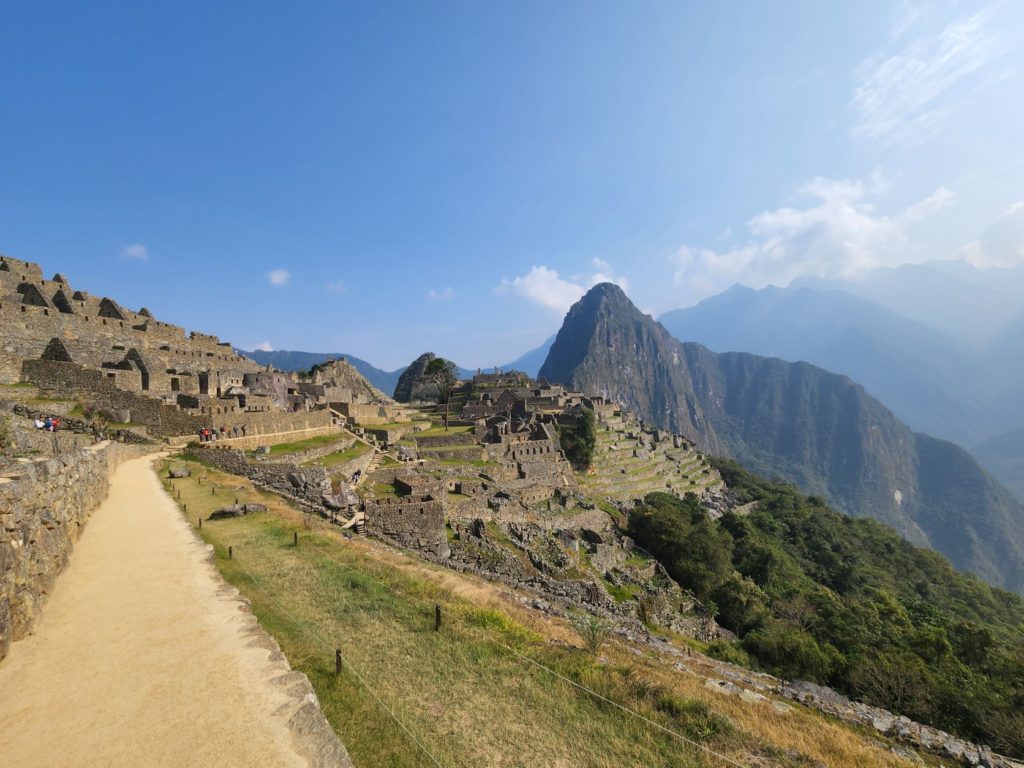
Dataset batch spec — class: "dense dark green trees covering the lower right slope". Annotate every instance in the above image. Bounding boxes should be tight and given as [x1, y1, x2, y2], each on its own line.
[630, 461, 1024, 757]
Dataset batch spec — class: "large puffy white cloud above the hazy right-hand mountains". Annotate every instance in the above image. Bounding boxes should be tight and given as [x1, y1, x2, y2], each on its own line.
[673, 178, 953, 309]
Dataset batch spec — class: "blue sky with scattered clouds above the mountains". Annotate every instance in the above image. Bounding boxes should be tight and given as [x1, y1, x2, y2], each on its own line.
[0, 1, 1024, 368]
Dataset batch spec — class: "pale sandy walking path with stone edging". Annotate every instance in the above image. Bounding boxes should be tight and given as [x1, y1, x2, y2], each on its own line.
[0, 456, 351, 768]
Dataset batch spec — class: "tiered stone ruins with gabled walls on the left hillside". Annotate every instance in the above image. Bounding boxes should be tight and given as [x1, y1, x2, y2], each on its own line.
[0, 256, 391, 442]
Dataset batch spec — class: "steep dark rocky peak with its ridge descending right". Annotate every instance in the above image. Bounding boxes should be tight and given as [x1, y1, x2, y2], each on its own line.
[540, 284, 1024, 591]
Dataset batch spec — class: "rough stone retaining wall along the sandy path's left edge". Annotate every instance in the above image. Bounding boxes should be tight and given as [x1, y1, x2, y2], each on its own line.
[0, 442, 153, 658]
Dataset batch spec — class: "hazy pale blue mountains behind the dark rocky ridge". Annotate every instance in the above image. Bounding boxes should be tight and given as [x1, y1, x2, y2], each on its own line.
[660, 262, 1024, 499]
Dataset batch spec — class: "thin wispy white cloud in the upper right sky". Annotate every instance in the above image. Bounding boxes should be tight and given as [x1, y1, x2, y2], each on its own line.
[850, 11, 997, 144]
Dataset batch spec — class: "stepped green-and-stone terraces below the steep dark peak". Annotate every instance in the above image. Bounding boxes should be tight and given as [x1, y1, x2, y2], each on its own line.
[579, 416, 722, 502]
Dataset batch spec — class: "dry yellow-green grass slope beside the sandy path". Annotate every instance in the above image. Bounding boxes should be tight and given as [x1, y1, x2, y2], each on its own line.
[161, 462, 929, 768]
